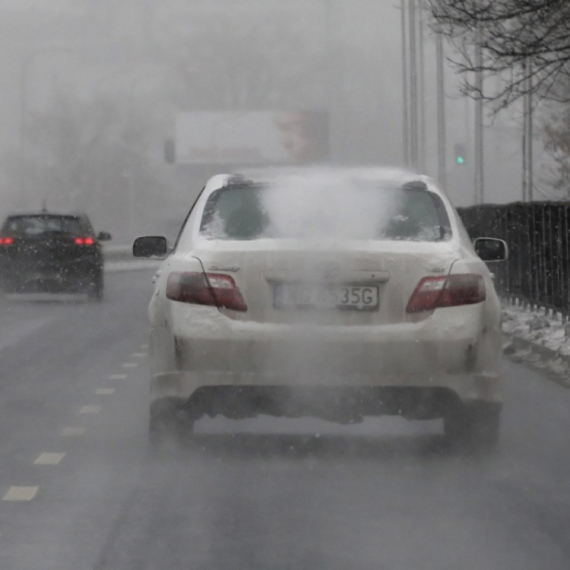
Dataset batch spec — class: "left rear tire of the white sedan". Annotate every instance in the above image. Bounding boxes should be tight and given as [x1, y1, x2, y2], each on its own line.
[148, 398, 194, 449]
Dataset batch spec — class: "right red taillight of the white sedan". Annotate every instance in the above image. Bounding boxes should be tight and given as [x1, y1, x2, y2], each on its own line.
[406, 273, 486, 313]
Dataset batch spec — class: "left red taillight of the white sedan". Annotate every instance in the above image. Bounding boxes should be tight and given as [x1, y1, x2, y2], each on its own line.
[166, 272, 247, 312]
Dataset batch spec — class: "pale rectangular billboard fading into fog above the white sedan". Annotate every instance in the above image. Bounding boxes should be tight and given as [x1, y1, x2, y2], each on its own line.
[175, 111, 329, 165]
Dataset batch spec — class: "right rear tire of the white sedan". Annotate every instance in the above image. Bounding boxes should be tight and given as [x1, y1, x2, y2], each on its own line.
[443, 403, 501, 451]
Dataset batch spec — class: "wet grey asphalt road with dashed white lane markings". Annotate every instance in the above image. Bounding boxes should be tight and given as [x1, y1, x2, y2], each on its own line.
[0, 270, 570, 570]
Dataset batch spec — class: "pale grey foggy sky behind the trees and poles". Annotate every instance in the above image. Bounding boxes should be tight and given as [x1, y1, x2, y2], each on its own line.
[0, 0, 532, 239]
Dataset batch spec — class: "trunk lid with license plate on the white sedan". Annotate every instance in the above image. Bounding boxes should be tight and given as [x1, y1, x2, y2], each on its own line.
[193, 239, 460, 325]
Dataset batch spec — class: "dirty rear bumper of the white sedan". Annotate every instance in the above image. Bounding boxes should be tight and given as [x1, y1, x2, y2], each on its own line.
[151, 305, 502, 403]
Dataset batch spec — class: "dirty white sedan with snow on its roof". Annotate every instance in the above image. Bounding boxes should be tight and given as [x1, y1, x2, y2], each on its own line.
[133, 169, 508, 447]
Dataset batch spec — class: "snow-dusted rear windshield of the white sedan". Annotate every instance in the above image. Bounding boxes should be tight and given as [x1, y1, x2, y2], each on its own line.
[200, 183, 451, 237]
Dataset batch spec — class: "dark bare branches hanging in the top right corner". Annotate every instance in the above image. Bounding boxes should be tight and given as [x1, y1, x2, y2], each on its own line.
[426, 0, 570, 108]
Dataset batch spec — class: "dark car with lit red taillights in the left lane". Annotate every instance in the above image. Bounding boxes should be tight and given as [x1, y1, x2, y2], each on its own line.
[0, 212, 111, 300]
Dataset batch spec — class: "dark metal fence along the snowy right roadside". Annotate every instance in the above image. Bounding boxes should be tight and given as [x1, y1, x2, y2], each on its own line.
[458, 202, 570, 316]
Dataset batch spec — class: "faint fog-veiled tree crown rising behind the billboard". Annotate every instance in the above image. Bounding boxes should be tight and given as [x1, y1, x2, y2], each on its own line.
[158, 17, 325, 110]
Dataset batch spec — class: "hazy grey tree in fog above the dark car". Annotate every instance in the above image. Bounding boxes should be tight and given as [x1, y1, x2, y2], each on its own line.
[2, 97, 170, 235]
